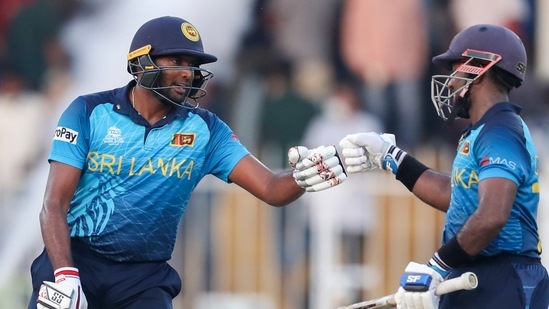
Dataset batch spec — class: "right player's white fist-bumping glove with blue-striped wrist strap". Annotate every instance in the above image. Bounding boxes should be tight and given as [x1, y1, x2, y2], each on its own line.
[339, 132, 406, 175]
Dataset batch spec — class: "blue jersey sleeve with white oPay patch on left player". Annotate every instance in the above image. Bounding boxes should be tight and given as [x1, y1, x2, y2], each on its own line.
[48, 97, 89, 169]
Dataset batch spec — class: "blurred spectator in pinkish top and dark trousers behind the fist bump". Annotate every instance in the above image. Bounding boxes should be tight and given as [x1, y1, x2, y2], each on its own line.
[340, 0, 428, 149]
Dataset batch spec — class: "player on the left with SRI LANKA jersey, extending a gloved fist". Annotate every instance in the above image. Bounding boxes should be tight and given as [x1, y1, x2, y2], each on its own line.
[29, 16, 346, 309]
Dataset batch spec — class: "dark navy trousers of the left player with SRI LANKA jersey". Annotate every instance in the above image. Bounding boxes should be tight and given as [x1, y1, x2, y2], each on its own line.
[28, 240, 181, 309]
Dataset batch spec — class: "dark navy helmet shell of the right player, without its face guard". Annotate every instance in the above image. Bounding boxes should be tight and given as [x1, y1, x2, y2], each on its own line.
[433, 24, 527, 87]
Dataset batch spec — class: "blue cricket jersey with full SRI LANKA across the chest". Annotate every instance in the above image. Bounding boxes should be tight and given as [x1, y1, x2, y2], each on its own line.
[49, 81, 249, 261]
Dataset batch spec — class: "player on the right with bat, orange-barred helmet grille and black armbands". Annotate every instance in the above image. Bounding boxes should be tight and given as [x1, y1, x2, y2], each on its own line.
[340, 24, 549, 309]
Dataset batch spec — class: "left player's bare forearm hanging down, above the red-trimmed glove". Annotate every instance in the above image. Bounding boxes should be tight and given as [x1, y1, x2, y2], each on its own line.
[40, 207, 74, 270]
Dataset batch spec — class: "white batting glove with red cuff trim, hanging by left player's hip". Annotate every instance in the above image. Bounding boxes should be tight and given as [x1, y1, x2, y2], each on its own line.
[37, 267, 88, 309]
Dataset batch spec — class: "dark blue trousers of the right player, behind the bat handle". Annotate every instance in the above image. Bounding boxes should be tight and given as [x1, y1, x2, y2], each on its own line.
[439, 254, 549, 309]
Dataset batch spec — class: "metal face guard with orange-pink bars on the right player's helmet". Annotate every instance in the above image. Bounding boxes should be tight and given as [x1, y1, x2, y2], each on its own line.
[431, 49, 501, 121]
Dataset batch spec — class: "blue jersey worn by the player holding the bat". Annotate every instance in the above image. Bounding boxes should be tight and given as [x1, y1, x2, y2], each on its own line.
[443, 102, 541, 258]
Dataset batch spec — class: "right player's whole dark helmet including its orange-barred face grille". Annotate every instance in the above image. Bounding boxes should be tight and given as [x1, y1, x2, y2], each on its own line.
[431, 24, 527, 121]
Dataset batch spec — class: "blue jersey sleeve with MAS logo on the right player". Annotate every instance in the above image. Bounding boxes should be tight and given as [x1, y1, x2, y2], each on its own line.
[475, 126, 531, 186]
